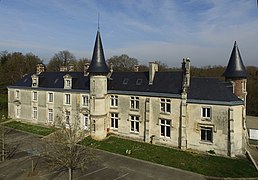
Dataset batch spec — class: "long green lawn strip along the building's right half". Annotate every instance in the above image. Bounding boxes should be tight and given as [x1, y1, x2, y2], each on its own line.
[81, 136, 258, 178]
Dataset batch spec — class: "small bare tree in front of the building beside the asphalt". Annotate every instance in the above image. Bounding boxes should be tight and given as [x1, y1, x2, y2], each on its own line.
[42, 108, 95, 180]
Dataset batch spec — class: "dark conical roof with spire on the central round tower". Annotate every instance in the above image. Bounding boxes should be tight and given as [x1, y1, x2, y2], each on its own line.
[88, 31, 109, 74]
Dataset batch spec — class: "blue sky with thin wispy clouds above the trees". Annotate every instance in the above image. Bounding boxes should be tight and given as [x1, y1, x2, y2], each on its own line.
[0, 0, 258, 67]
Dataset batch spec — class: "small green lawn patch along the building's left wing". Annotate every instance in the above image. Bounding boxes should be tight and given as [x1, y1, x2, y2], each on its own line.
[5, 121, 55, 136]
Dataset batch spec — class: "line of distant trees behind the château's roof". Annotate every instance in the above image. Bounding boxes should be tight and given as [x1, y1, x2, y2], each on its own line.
[0, 50, 258, 116]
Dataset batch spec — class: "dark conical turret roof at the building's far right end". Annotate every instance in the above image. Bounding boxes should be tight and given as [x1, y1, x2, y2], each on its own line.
[223, 41, 247, 78]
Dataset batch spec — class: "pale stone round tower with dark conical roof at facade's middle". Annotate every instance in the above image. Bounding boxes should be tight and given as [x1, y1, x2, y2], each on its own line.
[88, 31, 109, 140]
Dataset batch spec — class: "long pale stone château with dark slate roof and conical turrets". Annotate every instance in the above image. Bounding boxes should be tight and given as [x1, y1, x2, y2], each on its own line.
[8, 31, 247, 157]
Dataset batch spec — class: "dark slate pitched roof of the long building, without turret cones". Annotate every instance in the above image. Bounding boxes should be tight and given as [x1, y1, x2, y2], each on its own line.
[9, 71, 242, 104]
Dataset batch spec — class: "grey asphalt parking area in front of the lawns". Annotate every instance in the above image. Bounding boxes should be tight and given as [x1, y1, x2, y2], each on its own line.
[0, 130, 205, 180]
